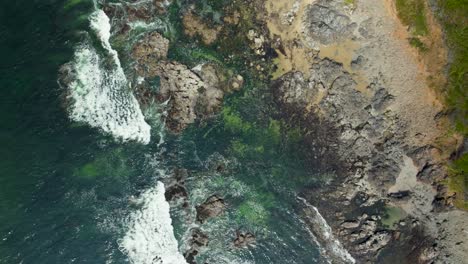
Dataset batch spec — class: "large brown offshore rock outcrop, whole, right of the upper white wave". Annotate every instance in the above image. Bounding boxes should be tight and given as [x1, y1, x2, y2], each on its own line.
[132, 32, 243, 133]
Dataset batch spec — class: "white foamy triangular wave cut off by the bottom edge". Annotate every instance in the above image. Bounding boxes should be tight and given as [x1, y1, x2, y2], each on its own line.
[119, 182, 187, 264]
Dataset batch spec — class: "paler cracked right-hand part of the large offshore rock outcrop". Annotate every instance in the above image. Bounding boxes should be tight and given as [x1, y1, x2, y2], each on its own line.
[158, 62, 243, 133]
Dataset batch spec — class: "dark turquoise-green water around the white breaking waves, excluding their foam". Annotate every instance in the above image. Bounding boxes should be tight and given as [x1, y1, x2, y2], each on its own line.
[0, 0, 336, 264]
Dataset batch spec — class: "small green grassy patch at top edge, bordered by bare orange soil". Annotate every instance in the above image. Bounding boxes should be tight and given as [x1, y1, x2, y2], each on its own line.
[396, 0, 428, 35]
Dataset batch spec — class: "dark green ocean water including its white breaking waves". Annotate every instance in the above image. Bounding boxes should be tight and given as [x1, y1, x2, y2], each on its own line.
[0, 0, 352, 264]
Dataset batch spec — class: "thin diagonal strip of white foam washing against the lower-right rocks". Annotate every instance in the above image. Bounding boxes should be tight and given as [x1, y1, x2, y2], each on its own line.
[297, 197, 356, 263]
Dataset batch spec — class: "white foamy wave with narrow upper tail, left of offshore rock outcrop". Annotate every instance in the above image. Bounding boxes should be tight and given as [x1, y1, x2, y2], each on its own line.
[61, 10, 151, 144]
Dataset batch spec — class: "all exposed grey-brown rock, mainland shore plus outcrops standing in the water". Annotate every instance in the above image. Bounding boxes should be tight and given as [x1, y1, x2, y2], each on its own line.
[96, 0, 468, 263]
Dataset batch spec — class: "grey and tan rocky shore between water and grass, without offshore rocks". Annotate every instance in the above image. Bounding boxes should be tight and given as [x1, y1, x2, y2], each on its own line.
[271, 1, 468, 263]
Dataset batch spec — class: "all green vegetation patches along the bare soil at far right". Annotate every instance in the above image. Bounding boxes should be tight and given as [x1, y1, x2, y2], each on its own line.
[395, 0, 468, 210]
